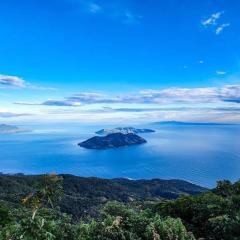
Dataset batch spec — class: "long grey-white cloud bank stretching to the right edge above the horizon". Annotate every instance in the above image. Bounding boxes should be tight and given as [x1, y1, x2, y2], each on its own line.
[18, 85, 240, 107]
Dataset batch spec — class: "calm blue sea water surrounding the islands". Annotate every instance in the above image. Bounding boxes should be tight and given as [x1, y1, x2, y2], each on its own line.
[0, 124, 240, 187]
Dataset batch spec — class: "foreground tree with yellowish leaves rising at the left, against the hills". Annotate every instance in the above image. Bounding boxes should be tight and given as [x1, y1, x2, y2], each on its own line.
[0, 174, 69, 240]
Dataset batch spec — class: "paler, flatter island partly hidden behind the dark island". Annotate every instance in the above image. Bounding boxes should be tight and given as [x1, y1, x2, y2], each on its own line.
[95, 127, 155, 135]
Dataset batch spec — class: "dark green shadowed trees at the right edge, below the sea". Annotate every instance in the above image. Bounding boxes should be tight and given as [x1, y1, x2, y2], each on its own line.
[152, 181, 240, 240]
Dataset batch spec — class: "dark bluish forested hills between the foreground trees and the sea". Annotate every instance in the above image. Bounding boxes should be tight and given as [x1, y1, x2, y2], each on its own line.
[0, 175, 207, 219]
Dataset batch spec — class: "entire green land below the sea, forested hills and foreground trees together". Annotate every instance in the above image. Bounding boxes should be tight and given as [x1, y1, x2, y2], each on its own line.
[0, 174, 240, 240]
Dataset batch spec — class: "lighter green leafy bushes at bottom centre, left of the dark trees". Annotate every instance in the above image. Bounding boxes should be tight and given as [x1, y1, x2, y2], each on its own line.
[77, 202, 195, 240]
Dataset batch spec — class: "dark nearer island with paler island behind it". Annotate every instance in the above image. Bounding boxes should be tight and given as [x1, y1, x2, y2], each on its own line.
[78, 133, 147, 150]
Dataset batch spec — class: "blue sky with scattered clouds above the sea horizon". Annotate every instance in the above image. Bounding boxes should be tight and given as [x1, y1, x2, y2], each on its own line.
[0, 0, 240, 122]
